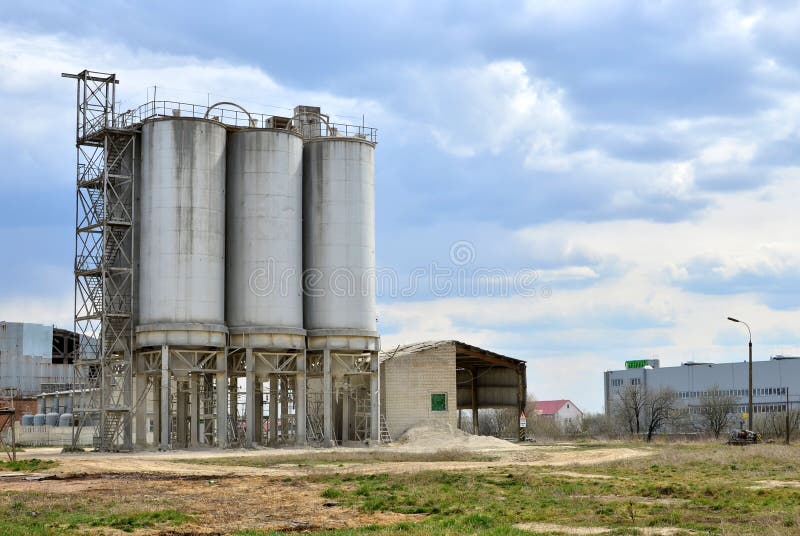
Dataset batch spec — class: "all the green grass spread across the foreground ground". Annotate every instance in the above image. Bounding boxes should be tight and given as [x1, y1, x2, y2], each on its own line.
[0, 443, 800, 536]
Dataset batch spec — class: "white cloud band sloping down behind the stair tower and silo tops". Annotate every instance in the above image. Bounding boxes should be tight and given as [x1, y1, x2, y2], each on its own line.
[0, 25, 390, 189]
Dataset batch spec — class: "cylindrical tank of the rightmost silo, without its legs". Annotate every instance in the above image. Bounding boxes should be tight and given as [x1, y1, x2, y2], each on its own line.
[303, 137, 377, 336]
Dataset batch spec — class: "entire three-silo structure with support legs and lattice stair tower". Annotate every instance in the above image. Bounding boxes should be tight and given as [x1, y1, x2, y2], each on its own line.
[64, 71, 380, 450]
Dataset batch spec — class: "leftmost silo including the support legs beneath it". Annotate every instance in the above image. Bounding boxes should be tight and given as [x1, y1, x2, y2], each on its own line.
[132, 117, 228, 449]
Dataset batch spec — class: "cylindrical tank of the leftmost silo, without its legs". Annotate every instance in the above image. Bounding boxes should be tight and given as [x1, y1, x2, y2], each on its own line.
[136, 118, 227, 346]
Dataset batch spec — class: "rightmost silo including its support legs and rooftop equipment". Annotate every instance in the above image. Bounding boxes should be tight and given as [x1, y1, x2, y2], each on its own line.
[302, 125, 380, 445]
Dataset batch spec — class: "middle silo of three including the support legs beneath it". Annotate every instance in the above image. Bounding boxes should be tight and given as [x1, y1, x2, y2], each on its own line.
[226, 129, 306, 446]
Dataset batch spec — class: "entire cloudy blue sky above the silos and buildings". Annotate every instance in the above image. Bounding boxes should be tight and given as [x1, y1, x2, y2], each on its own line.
[0, 0, 800, 411]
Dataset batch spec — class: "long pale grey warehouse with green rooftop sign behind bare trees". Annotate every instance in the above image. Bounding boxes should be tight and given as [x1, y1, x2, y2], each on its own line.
[603, 356, 800, 415]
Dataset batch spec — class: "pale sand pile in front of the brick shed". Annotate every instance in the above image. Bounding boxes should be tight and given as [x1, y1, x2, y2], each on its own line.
[396, 423, 521, 451]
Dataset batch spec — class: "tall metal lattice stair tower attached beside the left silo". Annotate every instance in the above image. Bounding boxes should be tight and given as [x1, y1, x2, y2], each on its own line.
[62, 71, 138, 450]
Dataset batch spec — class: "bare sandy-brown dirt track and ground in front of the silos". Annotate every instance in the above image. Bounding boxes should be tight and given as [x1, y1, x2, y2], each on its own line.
[0, 445, 651, 534]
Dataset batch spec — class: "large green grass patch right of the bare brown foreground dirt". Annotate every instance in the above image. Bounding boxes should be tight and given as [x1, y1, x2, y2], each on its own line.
[242, 444, 800, 535]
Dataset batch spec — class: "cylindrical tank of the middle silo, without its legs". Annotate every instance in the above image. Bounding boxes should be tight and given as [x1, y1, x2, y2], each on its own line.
[225, 129, 305, 348]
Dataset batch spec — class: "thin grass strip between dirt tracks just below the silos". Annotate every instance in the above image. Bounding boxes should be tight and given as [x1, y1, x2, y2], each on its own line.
[172, 450, 497, 467]
